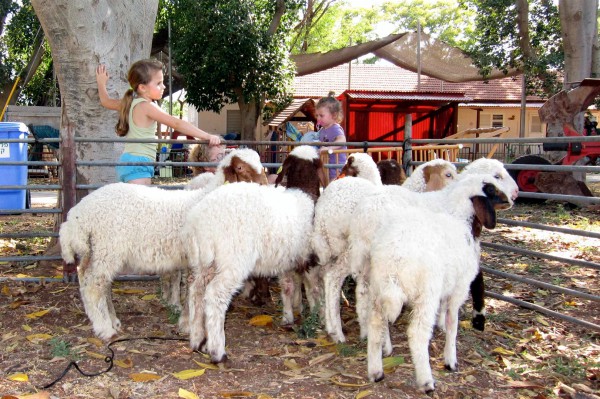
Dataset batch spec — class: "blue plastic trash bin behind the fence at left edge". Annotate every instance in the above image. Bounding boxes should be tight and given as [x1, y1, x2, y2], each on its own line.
[0, 122, 29, 209]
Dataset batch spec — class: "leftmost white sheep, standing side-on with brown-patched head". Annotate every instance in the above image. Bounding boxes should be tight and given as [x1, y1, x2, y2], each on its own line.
[59, 149, 266, 340]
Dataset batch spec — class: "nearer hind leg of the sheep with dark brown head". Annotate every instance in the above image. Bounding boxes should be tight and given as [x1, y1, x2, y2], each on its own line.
[204, 266, 247, 363]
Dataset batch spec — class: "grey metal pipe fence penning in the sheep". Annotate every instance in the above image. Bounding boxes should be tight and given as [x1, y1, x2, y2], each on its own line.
[0, 137, 600, 330]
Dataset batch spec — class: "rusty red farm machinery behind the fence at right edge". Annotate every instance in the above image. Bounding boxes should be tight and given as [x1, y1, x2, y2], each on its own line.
[510, 79, 600, 201]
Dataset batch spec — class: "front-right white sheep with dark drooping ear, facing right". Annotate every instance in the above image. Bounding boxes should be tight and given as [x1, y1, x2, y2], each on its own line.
[368, 175, 512, 393]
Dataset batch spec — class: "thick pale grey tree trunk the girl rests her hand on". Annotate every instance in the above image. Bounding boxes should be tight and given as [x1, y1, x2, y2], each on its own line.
[31, 0, 158, 189]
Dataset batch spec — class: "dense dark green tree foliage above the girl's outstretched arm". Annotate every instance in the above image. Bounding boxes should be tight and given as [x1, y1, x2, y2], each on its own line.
[161, 0, 296, 112]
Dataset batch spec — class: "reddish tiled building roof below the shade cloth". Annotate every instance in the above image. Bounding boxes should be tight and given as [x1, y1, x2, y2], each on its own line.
[294, 64, 543, 103]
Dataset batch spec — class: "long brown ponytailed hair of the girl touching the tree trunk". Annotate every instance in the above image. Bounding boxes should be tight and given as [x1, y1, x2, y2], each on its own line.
[116, 59, 163, 137]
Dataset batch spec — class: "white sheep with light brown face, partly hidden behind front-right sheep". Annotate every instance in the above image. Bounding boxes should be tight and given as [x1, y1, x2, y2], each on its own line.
[312, 157, 456, 342]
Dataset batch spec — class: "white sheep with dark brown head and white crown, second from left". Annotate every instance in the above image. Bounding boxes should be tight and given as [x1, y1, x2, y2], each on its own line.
[183, 146, 325, 363]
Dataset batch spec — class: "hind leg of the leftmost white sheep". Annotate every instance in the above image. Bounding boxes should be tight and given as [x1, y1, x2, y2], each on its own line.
[79, 263, 120, 341]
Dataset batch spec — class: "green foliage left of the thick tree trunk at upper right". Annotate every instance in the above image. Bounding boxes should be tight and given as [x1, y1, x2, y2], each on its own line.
[460, 0, 564, 96]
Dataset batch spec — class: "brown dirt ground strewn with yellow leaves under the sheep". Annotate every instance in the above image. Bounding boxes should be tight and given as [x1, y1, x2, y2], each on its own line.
[0, 179, 600, 399]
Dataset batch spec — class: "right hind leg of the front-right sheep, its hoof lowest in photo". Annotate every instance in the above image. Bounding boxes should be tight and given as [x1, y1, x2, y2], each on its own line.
[407, 298, 440, 393]
